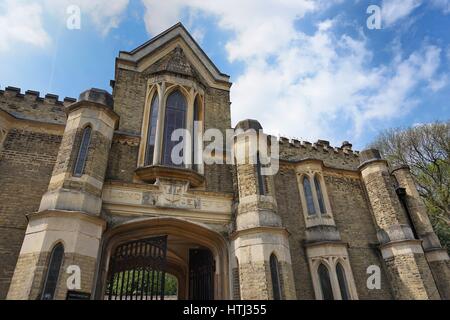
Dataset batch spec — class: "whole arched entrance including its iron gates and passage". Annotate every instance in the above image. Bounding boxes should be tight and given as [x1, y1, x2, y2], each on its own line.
[95, 217, 229, 300]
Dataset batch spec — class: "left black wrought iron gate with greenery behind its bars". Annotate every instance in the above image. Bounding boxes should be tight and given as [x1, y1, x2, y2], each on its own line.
[105, 236, 167, 300]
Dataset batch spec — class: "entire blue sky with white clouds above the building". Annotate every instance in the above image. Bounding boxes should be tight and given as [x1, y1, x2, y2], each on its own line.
[0, 0, 450, 149]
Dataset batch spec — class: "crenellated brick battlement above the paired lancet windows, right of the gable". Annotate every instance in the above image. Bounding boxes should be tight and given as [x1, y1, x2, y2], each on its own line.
[270, 137, 359, 170]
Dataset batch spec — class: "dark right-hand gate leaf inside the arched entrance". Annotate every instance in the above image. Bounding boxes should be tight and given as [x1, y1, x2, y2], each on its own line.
[189, 249, 215, 300]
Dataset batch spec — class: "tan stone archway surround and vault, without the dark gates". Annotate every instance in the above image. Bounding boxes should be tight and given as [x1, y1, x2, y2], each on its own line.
[95, 217, 230, 299]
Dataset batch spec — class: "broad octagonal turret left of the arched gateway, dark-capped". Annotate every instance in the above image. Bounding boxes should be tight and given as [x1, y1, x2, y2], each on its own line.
[7, 89, 119, 300]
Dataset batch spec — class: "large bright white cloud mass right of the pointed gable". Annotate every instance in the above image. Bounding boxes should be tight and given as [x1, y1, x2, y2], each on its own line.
[143, 0, 446, 142]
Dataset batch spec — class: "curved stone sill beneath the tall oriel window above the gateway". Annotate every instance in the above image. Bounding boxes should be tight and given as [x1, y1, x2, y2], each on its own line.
[135, 166, 205, 187]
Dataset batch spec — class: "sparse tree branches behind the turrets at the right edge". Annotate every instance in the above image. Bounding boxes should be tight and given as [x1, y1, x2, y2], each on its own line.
[370, 121, 450, 249]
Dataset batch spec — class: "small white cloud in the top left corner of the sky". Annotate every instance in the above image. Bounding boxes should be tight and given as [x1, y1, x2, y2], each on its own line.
[0, 0, 51, 52]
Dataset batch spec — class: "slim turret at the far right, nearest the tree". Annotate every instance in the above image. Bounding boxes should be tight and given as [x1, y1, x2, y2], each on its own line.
[392, 166, 450, 300]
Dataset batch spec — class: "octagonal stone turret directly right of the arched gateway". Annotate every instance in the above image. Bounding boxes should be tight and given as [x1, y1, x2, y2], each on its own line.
[232, 120, 296, 300]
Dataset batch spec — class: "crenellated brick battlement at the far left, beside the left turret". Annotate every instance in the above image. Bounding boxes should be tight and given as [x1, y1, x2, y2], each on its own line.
[0, 87, 77, 124]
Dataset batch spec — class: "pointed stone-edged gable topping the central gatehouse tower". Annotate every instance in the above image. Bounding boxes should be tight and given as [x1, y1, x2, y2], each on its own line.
[116, 23, 231, 90]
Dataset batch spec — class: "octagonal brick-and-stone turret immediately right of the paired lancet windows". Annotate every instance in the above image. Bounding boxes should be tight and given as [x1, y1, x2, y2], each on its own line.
[360, 149, 440, 300]
